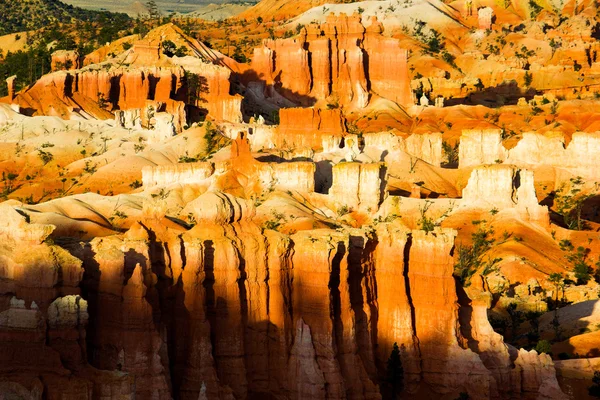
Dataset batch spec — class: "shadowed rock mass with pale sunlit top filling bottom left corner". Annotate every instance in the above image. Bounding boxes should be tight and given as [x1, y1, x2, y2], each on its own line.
[0, 206, 135, 400]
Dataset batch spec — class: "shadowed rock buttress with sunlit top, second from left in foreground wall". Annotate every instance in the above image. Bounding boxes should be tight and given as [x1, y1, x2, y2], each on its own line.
[80, 233, 170, 399]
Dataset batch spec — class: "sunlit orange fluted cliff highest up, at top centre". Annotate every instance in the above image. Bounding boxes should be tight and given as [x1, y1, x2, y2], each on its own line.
[252, 14, 412, 108]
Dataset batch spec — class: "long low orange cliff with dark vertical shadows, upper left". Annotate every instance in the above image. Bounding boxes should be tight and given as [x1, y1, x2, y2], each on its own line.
[14, 65, 241, 125]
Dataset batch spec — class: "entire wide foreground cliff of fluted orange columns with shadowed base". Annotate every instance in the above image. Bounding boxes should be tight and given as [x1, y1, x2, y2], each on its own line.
[0, 202, 561, 400]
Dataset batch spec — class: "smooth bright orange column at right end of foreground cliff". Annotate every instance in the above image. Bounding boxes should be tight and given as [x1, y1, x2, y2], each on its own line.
[408, 229, 492, 398]
